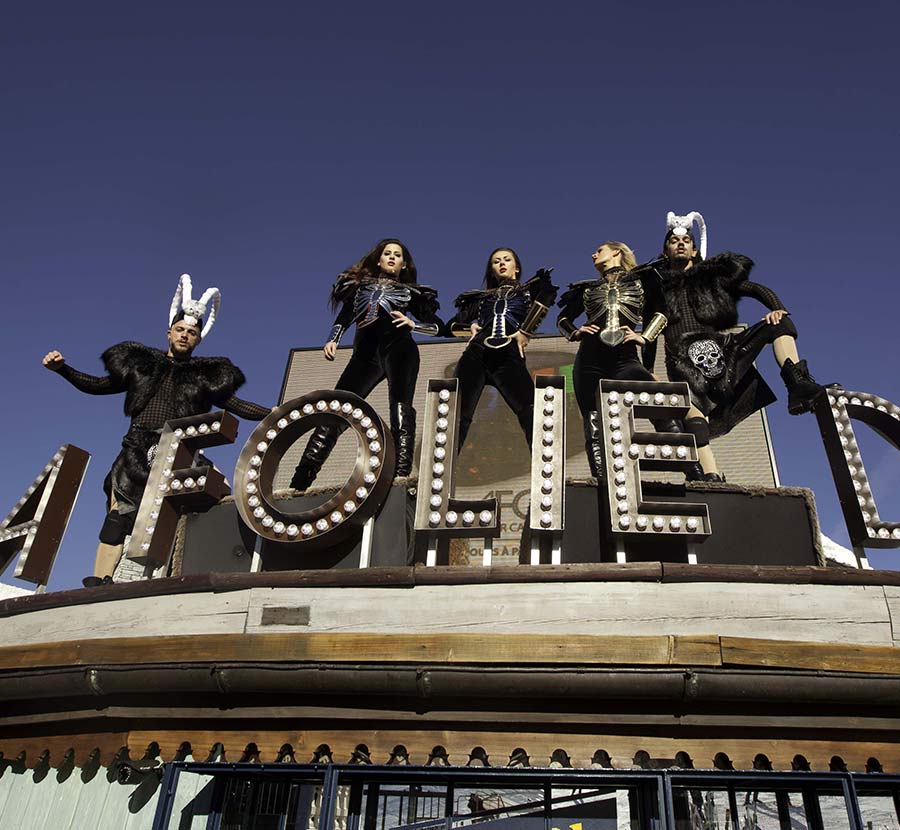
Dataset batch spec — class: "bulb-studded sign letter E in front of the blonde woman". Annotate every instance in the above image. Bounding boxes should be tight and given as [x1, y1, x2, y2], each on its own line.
[597, 380, 711, 559]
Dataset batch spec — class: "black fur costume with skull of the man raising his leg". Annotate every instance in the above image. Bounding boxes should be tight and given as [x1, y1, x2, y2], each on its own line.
[657, 252, 797, 437]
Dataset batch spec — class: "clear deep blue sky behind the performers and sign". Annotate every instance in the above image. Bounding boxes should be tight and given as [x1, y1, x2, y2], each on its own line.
[0, 0, 900, 589]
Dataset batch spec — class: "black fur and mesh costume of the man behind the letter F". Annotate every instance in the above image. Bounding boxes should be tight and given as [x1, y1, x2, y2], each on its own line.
[59, 342, 270, 545]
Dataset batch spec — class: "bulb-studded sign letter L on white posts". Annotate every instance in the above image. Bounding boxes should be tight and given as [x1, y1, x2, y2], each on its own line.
[415, 378, 499, 565]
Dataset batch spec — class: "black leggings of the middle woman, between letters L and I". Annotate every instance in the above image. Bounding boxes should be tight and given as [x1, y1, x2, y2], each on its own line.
[453, 340, 534, 450]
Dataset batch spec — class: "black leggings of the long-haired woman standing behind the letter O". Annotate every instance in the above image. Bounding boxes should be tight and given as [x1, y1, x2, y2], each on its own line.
[334, 318, 419, 409]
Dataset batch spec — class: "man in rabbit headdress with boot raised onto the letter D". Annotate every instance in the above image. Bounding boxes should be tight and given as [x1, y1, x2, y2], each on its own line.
[658, 211, 825, 481]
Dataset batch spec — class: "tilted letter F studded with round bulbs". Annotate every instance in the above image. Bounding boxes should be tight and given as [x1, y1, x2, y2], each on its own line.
[125, 412, 238, 568]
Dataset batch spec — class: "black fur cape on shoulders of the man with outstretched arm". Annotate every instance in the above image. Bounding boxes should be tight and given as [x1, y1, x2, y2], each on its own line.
[101, 341, 246, 418]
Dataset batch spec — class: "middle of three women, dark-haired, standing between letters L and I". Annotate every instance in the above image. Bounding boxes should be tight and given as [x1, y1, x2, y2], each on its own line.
[448, 248, 558, 450]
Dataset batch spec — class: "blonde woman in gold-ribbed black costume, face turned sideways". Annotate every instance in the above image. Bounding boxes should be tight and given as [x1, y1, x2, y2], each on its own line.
[556, 241, 683, 478]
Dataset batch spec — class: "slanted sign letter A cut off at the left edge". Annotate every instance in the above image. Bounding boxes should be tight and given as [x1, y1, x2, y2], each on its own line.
[0, 444, 91, 586]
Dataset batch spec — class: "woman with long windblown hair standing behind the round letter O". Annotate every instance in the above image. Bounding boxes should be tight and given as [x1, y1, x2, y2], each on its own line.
[291, 239, 443, 490]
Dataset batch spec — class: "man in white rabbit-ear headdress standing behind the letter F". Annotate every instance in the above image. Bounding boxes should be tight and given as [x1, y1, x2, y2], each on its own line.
[43, 274, 270, 585]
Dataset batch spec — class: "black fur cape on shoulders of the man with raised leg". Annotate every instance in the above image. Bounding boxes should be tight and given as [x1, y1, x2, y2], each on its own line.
[660, 251, 753, 331]
